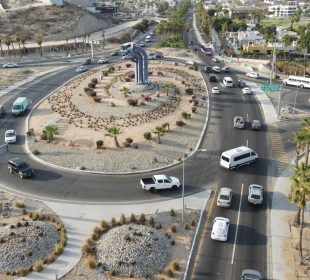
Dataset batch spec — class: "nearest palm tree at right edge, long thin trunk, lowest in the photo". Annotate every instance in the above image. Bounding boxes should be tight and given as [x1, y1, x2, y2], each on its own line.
[290, 162, 310, 264]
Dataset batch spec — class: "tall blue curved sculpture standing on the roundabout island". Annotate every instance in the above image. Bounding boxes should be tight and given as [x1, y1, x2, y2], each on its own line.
[131, 42, 149, 85]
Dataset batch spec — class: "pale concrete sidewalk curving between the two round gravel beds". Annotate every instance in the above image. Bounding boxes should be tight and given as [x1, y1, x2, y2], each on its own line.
[18, 190, 211, 280]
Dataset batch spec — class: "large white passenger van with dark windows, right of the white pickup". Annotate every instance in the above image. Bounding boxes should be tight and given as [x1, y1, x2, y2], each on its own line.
[220, 146, 258, 169]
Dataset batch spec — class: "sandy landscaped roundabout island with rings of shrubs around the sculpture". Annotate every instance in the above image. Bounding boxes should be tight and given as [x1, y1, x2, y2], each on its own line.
[28, 62, 208, 174]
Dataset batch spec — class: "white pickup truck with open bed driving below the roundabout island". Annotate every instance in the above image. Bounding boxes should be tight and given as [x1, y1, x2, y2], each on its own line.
[140, 175, 181, 192]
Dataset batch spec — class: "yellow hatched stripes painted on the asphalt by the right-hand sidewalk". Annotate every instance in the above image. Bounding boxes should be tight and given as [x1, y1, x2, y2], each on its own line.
[267, 125, 289, 175]
